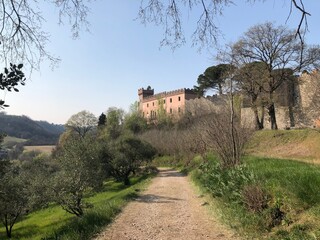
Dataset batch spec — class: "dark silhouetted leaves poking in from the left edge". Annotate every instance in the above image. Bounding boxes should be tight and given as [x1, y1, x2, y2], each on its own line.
[0, 63, 26, 109]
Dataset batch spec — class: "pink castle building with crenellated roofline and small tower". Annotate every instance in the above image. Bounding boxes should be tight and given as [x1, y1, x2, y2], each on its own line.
[138, 88, 197, 121]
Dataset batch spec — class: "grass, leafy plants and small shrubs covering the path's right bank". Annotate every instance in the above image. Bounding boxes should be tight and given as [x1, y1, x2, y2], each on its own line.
[193, 155, 320, 240]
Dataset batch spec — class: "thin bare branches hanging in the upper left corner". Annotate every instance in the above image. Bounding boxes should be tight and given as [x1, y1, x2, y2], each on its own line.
[0, 0, 89, 70]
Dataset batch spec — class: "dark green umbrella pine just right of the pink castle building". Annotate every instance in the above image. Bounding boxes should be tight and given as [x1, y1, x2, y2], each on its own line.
[195, 64, 232, 95]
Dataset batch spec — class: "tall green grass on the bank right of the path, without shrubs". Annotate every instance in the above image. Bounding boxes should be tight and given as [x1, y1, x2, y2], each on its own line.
[193, 156, 320, 240]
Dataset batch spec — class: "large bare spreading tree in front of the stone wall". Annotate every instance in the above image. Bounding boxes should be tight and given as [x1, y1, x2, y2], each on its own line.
[227, 22, 320, 129]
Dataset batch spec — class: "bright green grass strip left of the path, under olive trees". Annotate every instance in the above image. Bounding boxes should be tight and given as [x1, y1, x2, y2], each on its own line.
[0, 173, 154, 240]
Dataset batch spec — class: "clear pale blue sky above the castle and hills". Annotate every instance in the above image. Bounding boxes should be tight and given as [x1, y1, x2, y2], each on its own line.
[0, 0, 320, 124]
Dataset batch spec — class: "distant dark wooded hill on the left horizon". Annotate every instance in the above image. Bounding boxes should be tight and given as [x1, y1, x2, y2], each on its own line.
[0, 113, 64, 145]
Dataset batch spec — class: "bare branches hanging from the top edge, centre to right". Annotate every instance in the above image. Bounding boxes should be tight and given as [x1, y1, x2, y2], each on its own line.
[139, 0, 311, 49]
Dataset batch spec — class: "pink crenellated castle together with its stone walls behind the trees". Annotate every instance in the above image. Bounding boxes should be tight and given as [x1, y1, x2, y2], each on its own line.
[138, 70, 320, 129]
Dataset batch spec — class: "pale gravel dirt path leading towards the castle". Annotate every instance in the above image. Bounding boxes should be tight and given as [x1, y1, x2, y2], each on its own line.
[97, 169, 237, 240]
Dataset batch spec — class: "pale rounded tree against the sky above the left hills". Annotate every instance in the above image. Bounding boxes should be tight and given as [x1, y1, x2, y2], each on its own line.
[66, 110, 98, 138]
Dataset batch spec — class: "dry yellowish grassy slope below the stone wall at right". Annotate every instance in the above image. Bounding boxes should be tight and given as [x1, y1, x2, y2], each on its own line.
[246, 129, 320, 164]
